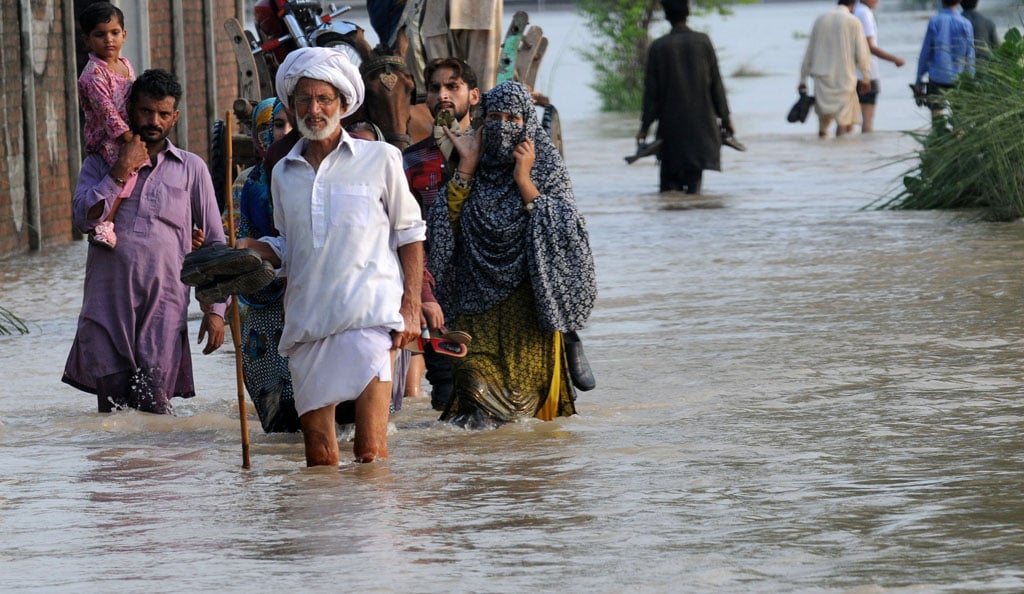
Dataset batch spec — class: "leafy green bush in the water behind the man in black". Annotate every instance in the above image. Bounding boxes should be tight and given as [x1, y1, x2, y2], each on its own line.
[575, 0, 753, 112]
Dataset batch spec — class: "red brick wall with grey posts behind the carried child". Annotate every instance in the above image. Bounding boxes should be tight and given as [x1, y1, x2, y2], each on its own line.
[0, 0, 238, 257]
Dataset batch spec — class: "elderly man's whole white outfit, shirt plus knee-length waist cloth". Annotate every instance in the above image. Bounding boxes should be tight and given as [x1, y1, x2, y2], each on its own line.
[262, 132, 426, 416]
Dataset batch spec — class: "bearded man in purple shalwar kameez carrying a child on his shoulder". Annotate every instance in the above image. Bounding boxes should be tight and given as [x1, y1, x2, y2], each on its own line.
[62, 70, 224, 414]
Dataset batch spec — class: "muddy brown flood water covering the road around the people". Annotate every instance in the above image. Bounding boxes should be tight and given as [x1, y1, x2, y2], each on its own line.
[0, 3, 1024, 594]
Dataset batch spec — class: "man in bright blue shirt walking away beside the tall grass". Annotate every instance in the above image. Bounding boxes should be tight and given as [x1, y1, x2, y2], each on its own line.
[915, 0, 974, 118]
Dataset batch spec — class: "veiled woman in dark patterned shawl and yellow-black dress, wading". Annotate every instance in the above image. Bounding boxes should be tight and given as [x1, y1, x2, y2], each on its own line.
[427, 82, 597, 427]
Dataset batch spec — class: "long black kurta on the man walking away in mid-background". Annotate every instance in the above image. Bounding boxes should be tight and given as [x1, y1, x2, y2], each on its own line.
[641, 25, 729, 171]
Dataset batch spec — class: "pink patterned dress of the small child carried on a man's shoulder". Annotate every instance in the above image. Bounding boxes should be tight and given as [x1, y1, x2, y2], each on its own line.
[78, 53, 135, 165]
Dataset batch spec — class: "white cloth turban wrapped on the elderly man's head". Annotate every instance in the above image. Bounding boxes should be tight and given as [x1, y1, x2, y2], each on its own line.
[274, 47, 365, 118]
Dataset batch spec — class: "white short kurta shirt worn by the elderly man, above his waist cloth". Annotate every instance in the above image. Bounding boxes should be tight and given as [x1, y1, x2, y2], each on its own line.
[267, 132, 426, 355]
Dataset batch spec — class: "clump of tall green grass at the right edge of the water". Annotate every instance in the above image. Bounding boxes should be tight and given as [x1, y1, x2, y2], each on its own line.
[878, 29, 1024, 220]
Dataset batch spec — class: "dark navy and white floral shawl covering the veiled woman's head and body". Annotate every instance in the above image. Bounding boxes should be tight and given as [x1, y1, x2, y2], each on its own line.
[427, 81, 597, 331]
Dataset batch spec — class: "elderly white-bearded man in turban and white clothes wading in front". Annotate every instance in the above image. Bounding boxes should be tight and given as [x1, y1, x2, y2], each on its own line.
[240, 47, 426, 466]
